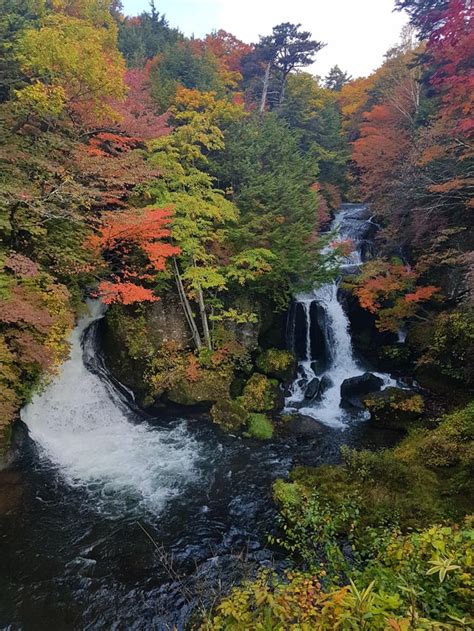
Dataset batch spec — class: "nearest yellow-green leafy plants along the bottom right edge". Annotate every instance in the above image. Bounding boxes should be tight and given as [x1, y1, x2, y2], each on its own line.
[204, 521, 473, 631]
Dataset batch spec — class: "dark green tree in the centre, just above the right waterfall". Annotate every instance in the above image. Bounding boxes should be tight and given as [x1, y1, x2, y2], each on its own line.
[211, 114, 338, 307]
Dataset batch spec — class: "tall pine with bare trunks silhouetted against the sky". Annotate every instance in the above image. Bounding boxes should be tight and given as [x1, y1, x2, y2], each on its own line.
[255, 22, 324, 114]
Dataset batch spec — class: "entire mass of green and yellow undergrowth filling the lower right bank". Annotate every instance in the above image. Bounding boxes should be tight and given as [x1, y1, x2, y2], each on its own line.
[197, 402, 474, 631]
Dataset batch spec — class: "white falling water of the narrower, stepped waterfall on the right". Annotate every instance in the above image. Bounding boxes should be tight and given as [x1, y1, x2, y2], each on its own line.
[285, 207, 395, 427]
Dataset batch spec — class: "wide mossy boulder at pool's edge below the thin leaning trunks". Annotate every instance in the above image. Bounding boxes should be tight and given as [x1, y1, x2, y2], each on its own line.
[167, 370, 232, 405]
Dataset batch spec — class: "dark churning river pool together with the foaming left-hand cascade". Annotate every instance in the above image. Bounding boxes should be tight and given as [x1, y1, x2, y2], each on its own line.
[0, 205, 397, 631]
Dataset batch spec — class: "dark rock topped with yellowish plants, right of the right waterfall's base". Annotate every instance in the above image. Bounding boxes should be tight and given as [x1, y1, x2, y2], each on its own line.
[363, 388, 425, 429]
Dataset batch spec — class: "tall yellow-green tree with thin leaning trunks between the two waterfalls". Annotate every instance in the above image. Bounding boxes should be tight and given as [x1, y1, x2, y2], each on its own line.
[148, 88, 273, 349]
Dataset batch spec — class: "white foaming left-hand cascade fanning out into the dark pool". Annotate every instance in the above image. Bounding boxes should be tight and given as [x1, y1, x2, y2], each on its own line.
[22, 303, 200, 514]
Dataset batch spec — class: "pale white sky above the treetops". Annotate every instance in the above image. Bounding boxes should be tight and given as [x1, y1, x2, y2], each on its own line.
[122, 0, 407, 77]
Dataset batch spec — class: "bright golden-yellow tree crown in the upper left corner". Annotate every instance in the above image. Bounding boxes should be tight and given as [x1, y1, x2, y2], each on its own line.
[16, 8, 125, 122]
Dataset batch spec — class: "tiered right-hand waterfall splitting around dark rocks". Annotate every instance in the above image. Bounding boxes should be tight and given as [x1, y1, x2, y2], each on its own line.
[285, 204, 395, 427]
